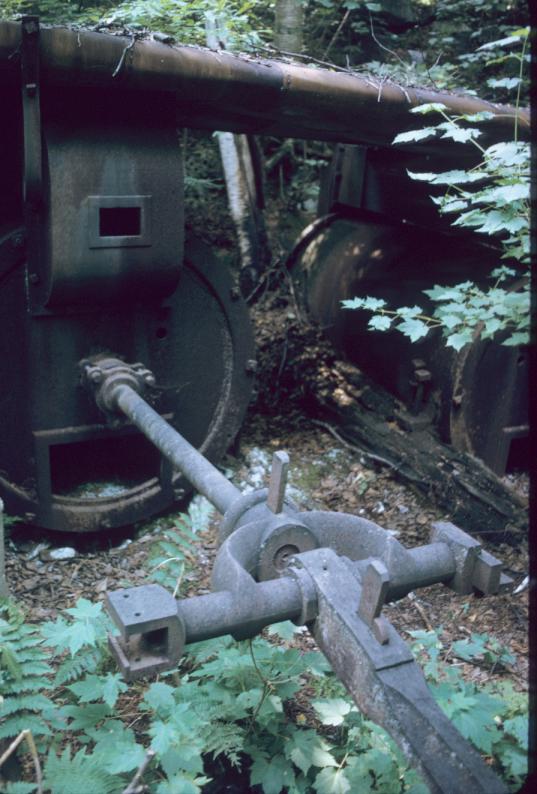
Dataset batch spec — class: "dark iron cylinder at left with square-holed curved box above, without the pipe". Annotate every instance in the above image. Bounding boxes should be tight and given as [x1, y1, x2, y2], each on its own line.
[0, 18, 254, 532]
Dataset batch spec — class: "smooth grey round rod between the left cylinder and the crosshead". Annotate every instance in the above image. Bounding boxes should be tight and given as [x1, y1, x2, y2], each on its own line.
[112, 384, 240, 514]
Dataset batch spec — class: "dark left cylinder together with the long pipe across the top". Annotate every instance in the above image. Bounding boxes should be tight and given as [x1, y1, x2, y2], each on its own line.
[0, 17, 529, 532]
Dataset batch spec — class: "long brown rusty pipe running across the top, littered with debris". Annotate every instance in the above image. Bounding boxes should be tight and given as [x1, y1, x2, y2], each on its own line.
[0, 22, 530, 153]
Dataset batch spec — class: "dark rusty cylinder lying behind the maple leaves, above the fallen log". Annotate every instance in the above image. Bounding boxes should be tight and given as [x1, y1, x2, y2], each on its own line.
[290, 210, 528, 474]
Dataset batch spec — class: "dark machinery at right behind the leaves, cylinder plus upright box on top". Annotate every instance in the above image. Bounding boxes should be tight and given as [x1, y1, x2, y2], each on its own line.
[288, 146, 529, 475]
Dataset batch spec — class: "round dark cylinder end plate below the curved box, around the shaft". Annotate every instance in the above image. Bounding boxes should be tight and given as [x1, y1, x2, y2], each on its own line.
[0, 235, 253, 532]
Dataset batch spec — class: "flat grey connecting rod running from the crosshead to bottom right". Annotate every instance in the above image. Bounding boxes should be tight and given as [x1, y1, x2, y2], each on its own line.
[299, 549, 507, 794]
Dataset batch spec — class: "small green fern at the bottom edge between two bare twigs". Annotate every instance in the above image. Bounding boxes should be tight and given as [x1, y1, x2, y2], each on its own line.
[44, 747, 121, 794]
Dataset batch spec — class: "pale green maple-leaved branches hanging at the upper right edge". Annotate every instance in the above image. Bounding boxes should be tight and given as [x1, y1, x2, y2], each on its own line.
[342, 28, 530, 351]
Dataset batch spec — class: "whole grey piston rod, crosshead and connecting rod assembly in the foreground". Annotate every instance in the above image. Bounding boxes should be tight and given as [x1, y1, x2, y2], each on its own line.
[93, 358, 509, 794]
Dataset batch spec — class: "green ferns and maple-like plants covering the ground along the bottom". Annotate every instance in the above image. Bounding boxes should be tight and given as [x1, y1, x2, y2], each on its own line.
[0, 503, 527, 794]
